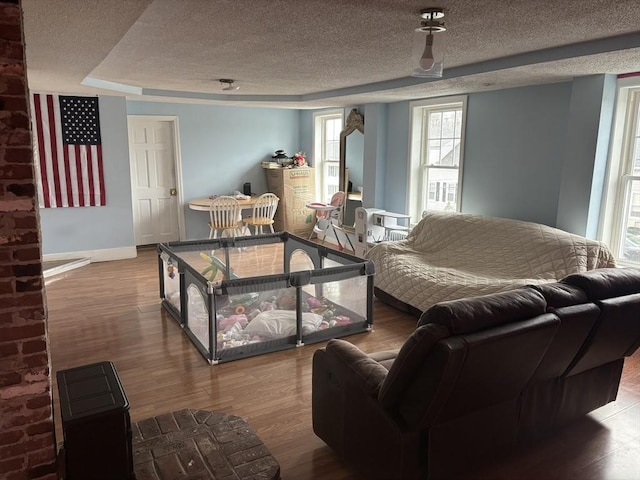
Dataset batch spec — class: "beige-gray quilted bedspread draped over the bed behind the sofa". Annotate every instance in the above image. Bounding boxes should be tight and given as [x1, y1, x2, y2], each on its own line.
[367, 213, 615, 311]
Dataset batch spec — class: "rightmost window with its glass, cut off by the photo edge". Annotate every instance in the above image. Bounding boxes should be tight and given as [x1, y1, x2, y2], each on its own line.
[602, 77, 640, 264]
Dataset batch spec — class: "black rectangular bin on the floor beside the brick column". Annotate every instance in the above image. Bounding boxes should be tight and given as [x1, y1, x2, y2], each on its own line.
[57, 362, 135, 480]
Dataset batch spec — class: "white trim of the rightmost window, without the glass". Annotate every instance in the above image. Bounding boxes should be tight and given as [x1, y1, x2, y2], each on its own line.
[598, 76, 640, 265]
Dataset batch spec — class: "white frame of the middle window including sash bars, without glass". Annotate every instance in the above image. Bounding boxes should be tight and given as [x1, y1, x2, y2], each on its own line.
[406, 95, 467, 223]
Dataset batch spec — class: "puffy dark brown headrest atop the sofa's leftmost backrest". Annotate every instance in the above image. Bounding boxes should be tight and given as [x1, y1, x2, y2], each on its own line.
[418, 288, 547, 335]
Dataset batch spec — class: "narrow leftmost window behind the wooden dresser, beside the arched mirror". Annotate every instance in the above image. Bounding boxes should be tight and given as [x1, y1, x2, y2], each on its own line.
[313, 110, 343, 202]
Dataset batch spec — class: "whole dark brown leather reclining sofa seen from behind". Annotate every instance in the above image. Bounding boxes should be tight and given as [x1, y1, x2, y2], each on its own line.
[312, 268, 640, 479]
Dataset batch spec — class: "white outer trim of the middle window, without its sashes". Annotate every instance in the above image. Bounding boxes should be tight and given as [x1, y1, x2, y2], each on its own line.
[406, 95, 467, 223]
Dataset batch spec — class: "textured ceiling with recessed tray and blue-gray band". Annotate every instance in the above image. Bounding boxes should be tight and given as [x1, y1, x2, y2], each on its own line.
[22, 0, 640, 108]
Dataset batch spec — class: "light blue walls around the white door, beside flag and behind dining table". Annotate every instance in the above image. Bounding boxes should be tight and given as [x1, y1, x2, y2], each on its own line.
[40, 96, 304, 255]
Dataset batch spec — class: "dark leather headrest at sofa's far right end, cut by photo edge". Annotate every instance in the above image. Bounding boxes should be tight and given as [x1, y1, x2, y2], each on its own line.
[562, 268, 640, 300]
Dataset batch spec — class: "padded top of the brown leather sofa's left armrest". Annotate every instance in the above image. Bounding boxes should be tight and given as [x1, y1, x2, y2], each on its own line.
[326, 339, 389, 397]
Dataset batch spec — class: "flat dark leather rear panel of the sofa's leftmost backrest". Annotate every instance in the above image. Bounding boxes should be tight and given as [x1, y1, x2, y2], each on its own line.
[416, 313, 560, 424]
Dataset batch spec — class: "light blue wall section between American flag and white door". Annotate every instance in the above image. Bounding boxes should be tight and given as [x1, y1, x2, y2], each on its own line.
[40, 96, 134, 255]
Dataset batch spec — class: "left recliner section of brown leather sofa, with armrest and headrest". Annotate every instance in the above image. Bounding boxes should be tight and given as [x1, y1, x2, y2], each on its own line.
[312, 288, 560, 479]
